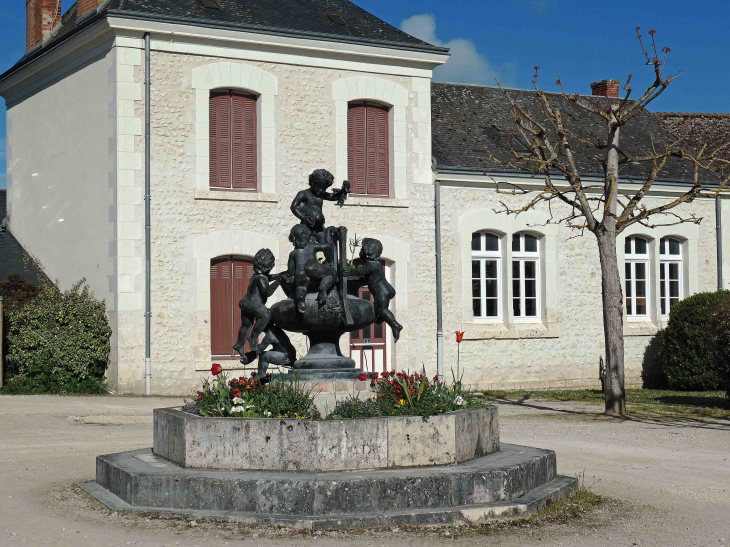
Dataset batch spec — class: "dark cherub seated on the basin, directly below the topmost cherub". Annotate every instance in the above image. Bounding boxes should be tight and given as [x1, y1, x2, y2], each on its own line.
[286, 224, 337, 313]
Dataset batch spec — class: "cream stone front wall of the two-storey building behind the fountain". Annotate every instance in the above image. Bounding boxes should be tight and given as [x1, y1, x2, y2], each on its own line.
[111, 51, 436, 393]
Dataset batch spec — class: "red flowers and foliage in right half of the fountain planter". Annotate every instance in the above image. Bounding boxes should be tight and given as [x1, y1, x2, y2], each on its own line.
[327, 372, 471, 419]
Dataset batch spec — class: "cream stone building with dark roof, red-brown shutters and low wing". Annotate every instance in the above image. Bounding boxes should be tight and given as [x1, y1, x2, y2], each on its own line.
[0, 0, 730, 393]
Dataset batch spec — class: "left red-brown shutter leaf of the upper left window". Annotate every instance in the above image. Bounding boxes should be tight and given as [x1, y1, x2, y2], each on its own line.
[209, 92, 231, 188]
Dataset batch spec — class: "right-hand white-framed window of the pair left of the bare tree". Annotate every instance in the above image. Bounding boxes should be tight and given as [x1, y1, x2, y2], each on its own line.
[512, 234, 540, 319]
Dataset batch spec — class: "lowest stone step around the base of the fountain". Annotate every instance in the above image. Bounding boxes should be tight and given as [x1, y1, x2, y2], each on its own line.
[81, 476, 578, 530]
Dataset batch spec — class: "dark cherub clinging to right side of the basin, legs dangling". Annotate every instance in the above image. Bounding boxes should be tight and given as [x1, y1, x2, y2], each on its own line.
[347, 237, 403, 342]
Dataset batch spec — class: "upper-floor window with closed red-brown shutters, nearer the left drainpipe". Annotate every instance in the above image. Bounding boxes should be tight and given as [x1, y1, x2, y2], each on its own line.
[209, 91, 257, 190]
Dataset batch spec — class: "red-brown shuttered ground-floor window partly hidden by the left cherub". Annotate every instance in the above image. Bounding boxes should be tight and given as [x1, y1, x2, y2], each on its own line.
[210, 257, 253, 358]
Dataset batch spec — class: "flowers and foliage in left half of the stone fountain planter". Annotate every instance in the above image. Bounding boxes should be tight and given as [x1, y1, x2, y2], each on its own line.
[183, 374, 321, 419]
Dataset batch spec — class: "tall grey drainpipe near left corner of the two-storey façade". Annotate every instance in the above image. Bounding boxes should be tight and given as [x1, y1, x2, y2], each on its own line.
[144, 32, 152, 395]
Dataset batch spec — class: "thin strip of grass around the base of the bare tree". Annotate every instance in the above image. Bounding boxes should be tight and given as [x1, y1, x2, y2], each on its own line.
[472, 389, 730, 420]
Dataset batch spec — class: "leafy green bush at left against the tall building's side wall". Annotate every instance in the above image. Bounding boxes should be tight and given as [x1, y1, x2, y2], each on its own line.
[3, 280, 112, 393]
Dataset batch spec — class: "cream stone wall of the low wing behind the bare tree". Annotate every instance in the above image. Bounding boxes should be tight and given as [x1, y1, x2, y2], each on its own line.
[441, 183, 717, 389]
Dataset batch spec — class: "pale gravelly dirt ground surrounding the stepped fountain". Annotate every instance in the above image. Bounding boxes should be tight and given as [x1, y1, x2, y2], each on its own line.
[0, 396, 730, 547]
